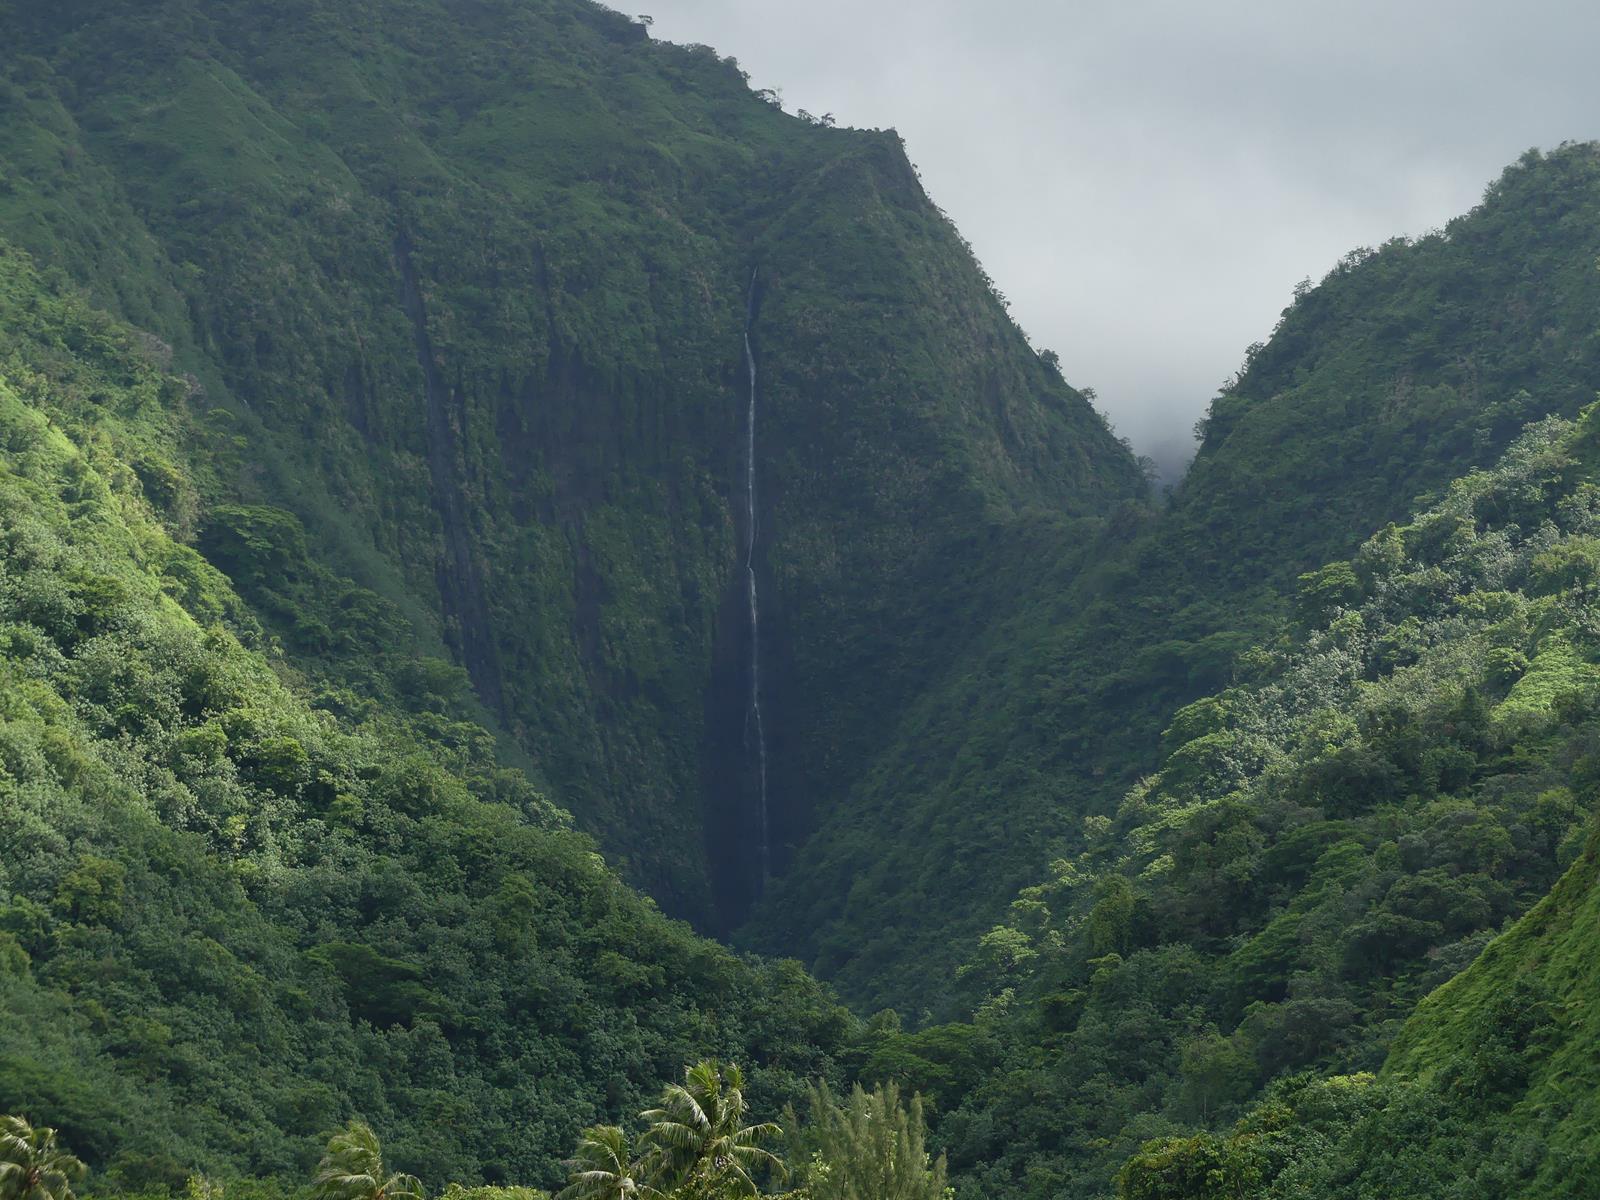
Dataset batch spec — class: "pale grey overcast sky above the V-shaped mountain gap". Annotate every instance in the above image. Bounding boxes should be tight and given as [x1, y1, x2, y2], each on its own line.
[643, 0, 1600, 480]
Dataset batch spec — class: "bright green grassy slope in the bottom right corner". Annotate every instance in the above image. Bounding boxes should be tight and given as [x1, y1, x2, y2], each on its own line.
[1126, 838, 1600, 1200]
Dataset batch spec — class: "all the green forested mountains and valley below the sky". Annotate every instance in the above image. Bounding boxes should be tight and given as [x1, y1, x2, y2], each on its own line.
[0, 0, 1600, 1200]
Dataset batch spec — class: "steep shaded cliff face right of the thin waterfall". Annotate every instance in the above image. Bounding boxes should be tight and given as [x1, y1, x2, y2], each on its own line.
[726, 139, 1141, 928]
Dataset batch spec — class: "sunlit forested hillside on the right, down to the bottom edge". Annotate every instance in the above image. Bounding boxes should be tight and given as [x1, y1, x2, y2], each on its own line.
[934, 408, 1600, 1198]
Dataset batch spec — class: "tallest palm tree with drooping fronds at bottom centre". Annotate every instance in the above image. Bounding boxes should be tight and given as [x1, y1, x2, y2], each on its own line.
[638, 1062, 784, 1197]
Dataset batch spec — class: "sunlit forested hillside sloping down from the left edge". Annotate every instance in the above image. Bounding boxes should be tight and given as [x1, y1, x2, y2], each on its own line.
[0, 248, 850, 1194]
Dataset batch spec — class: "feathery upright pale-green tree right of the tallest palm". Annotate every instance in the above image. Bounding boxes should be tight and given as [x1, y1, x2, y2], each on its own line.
[787, 1083, 946, 1200]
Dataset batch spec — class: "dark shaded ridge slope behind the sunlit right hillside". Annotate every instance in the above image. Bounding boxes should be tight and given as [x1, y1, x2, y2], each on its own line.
[750, 146, 1600, 1016]
